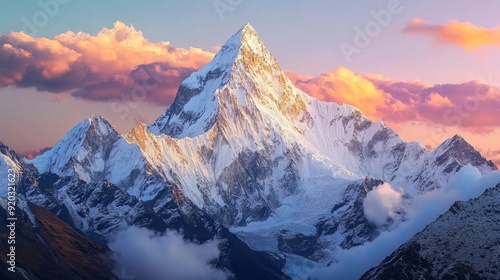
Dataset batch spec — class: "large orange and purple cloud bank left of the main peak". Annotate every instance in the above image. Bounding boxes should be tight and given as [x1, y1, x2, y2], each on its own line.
[0, 22, 214, 104]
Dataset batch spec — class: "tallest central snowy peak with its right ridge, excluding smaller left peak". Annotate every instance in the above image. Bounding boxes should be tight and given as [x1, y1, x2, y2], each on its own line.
[138, 24, 494, 230]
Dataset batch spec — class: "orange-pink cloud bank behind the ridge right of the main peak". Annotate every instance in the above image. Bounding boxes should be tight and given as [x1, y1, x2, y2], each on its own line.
[287, 68, 500, 133]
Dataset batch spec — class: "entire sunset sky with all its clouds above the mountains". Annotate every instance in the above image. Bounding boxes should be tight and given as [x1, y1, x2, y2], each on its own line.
[0, 0, 500, 164]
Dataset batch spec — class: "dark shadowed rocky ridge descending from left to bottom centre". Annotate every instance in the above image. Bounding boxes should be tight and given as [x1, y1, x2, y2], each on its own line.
[15, 154, 289, 279]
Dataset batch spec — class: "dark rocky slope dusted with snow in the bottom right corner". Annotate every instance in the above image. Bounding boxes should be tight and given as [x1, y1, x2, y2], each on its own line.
[362, 184, 500, 279]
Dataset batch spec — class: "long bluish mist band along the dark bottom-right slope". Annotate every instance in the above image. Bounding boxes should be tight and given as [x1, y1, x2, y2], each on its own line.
[309, 165, 500, 279]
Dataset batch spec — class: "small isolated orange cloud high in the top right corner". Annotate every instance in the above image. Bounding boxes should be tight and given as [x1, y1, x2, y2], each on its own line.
[404, 18, 500, 51]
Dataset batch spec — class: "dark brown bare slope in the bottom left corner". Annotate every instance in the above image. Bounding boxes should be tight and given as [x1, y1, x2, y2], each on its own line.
[0, 198, 115, 280]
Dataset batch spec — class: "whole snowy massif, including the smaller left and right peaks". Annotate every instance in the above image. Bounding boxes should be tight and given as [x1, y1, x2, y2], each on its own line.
[13, 24, 496, 278]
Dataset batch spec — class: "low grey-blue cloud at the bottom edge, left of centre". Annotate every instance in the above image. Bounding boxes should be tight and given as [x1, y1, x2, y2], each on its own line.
[108, 226, 229, 280]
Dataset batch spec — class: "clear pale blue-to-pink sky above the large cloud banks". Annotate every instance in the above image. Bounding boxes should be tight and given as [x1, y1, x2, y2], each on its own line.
[0, 0, 500, 83]
